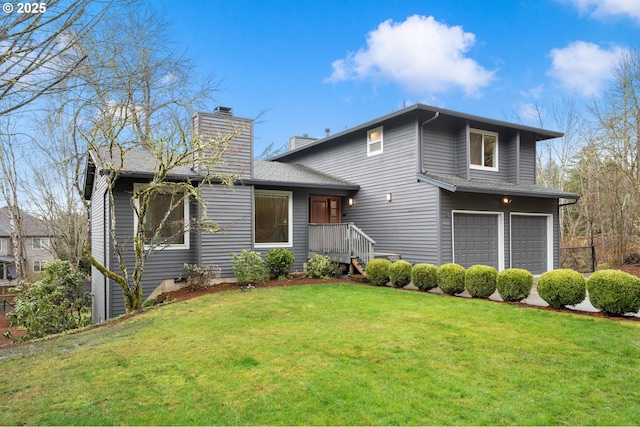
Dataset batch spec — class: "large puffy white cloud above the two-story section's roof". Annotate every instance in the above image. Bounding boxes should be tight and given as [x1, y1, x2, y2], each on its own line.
[326, 15, 494, 95]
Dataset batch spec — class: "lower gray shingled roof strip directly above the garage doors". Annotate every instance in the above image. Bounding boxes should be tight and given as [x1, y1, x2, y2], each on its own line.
[418, 173, 579, 200]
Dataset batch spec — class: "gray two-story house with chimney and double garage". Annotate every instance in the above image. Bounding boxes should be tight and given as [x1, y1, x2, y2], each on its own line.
[85, 104, 577, 322]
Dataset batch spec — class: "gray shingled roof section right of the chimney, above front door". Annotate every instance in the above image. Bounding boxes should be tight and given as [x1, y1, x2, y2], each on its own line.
[251, 160, 360, 191]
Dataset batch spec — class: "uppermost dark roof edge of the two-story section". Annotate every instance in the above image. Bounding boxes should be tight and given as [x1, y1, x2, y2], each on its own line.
[269, 104, 563, 160]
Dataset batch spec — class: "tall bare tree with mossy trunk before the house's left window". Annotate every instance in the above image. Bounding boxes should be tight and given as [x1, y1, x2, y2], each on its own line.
[65, 4, 242, 312]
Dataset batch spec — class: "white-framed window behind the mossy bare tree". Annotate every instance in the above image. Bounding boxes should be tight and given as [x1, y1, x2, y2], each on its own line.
[133, 184, 189, 249]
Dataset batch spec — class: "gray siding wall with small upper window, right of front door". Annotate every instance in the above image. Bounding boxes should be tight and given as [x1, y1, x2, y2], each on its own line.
[280, 118, 438, 262]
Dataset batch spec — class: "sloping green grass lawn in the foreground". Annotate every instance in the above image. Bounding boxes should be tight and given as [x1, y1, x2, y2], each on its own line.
[0, 284, 640, 425]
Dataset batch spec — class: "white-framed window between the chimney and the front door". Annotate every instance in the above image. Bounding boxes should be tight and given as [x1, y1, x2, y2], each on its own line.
[253, 190, 293, 248]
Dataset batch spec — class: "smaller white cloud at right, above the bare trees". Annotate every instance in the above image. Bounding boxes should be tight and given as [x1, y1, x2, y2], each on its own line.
[547, 41, 626, 96]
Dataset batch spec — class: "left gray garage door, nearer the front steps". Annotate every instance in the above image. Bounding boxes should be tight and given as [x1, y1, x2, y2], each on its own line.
[454, 213, 499, 268]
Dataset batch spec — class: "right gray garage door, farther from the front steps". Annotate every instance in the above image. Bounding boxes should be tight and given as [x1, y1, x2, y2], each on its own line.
[511, 215, 548, 274]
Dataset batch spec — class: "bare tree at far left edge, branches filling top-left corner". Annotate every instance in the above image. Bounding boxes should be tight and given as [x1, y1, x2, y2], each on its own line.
[0, 0, 108, 280]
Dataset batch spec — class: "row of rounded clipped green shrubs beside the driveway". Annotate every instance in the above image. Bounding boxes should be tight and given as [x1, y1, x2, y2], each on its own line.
[366, 259, 640, 316]
